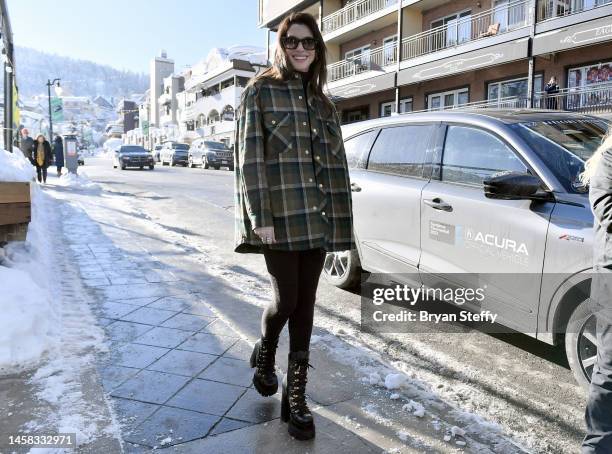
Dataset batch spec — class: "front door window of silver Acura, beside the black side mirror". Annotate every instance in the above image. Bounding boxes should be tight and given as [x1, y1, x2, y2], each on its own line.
[442, 126, 527, 185]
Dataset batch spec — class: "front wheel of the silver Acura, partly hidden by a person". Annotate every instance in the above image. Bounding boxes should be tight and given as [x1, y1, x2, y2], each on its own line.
[565, 299, 597, 389]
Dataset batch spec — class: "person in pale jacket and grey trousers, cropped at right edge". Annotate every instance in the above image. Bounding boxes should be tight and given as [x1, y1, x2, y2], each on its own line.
[580, 128, 612, 454]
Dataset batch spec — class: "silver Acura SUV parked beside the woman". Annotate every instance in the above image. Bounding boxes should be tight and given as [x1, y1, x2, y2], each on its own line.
[324, 109, 608, 386]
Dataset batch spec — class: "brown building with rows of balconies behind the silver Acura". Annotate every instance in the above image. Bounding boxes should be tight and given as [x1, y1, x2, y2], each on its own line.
[259, 0, 612, 123]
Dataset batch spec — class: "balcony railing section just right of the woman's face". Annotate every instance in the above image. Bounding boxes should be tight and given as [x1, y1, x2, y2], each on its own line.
[327, 43, 397, 82]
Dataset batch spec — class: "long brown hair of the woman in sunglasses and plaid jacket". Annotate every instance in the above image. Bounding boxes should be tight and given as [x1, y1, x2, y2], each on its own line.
[250, 12, 335, 111]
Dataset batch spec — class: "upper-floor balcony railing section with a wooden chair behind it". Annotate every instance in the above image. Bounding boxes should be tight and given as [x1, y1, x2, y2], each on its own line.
[402, 0, 529, 60]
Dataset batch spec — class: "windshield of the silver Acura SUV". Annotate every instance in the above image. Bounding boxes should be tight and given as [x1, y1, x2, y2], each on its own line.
[510, 119, 608, 192]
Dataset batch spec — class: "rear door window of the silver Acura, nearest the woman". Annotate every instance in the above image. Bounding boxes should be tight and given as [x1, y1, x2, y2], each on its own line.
[368, 125, 434, 177]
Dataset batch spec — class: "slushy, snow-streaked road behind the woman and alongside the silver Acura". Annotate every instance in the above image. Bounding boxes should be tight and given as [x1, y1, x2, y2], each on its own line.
[74, 158, 585, 453]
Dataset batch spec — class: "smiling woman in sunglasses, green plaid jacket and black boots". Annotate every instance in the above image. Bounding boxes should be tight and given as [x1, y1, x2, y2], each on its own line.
[234, 13, 354, 440]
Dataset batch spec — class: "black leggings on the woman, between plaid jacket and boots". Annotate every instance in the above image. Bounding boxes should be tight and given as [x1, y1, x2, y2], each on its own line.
[261, 247, 325, 352]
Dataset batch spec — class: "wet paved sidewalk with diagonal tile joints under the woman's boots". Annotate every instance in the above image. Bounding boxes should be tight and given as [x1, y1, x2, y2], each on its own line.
[0, 183, 524, 454]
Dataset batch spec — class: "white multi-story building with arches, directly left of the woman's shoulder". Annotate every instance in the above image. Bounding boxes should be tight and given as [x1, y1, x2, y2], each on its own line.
[179, 55, 263, 146]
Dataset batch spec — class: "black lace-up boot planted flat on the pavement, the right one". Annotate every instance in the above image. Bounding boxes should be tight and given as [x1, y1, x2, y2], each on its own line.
[281, 351, 315, 440]
